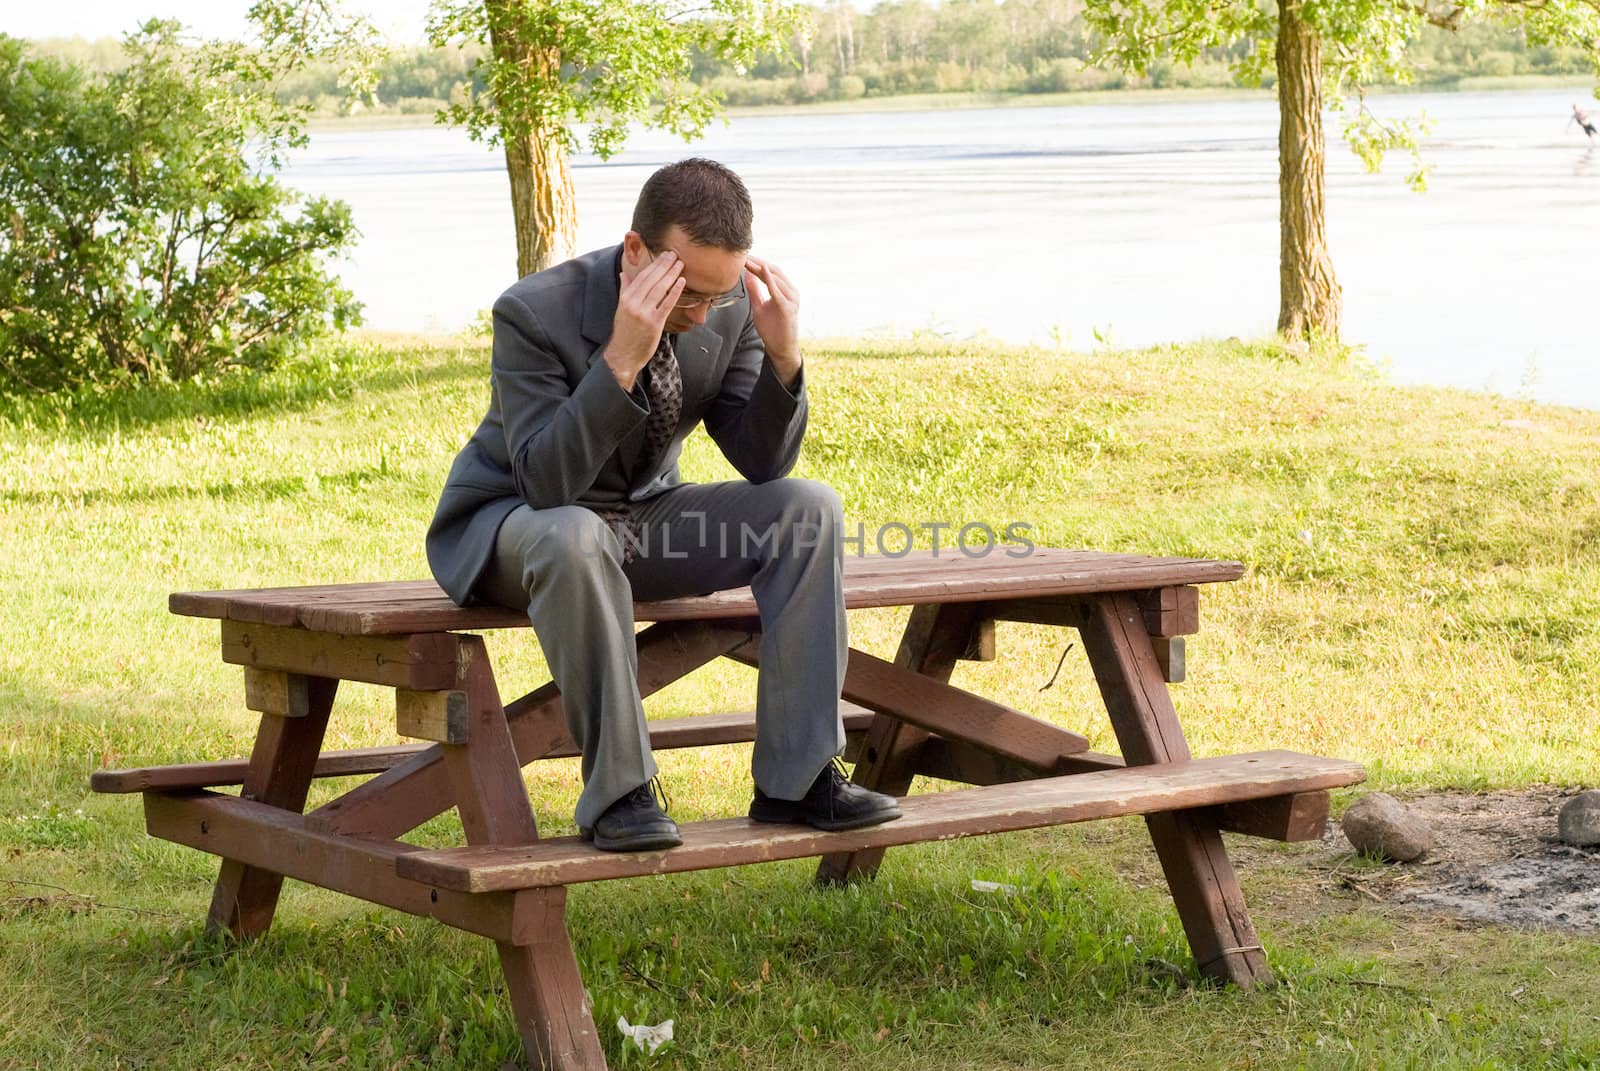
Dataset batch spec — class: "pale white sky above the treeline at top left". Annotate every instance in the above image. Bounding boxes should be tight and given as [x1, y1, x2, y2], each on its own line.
[0, 0, 429, 43]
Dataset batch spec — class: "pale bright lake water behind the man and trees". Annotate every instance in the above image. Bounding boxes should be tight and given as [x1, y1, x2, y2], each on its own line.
[290, 90, 1600, 408]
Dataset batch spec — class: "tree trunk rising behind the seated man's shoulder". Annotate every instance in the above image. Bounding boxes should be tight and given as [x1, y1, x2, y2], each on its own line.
[485, 0, 578, 279]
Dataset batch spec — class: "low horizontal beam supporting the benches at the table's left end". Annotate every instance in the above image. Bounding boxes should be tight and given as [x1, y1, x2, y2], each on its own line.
[144, 792, 528, 941]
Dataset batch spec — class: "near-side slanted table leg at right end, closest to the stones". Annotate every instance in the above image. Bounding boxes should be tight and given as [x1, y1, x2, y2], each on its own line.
[1082, 592, 1272, 988]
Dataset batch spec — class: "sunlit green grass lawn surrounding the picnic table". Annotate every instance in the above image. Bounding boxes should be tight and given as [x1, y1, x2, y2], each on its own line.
[0, 338, 1600, 1071]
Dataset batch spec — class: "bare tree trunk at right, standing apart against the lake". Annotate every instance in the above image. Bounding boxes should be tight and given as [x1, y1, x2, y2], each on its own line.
[1277, 0, 1341, 339]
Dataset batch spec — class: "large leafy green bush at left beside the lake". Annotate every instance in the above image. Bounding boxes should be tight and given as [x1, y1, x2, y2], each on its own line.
[0, 22, 358, 392]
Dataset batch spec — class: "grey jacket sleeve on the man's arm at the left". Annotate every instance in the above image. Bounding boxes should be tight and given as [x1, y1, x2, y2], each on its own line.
[491, 286, 650, 509]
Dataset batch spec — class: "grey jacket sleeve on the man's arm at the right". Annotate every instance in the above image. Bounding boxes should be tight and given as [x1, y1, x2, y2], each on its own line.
[700, 308, 806, 483]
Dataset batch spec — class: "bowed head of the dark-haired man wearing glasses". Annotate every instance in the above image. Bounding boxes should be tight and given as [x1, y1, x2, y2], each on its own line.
[622, 157, 752, 331]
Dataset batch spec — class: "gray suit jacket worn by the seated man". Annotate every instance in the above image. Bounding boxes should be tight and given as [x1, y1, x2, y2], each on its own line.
[427, 247, 806, 605]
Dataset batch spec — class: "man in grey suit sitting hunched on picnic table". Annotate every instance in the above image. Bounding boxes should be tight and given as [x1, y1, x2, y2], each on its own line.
[427, 158, 899, 852]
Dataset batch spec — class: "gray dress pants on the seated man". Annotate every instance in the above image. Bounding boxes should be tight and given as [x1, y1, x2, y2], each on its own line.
[474, 479, 848, 828]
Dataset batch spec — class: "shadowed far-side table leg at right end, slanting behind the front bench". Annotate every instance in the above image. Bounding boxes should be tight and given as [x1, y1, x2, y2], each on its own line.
[816, 602, 982, 885]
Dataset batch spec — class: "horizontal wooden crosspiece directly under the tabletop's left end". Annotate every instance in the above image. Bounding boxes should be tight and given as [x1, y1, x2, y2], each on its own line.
[222, 621, 456, 690]
